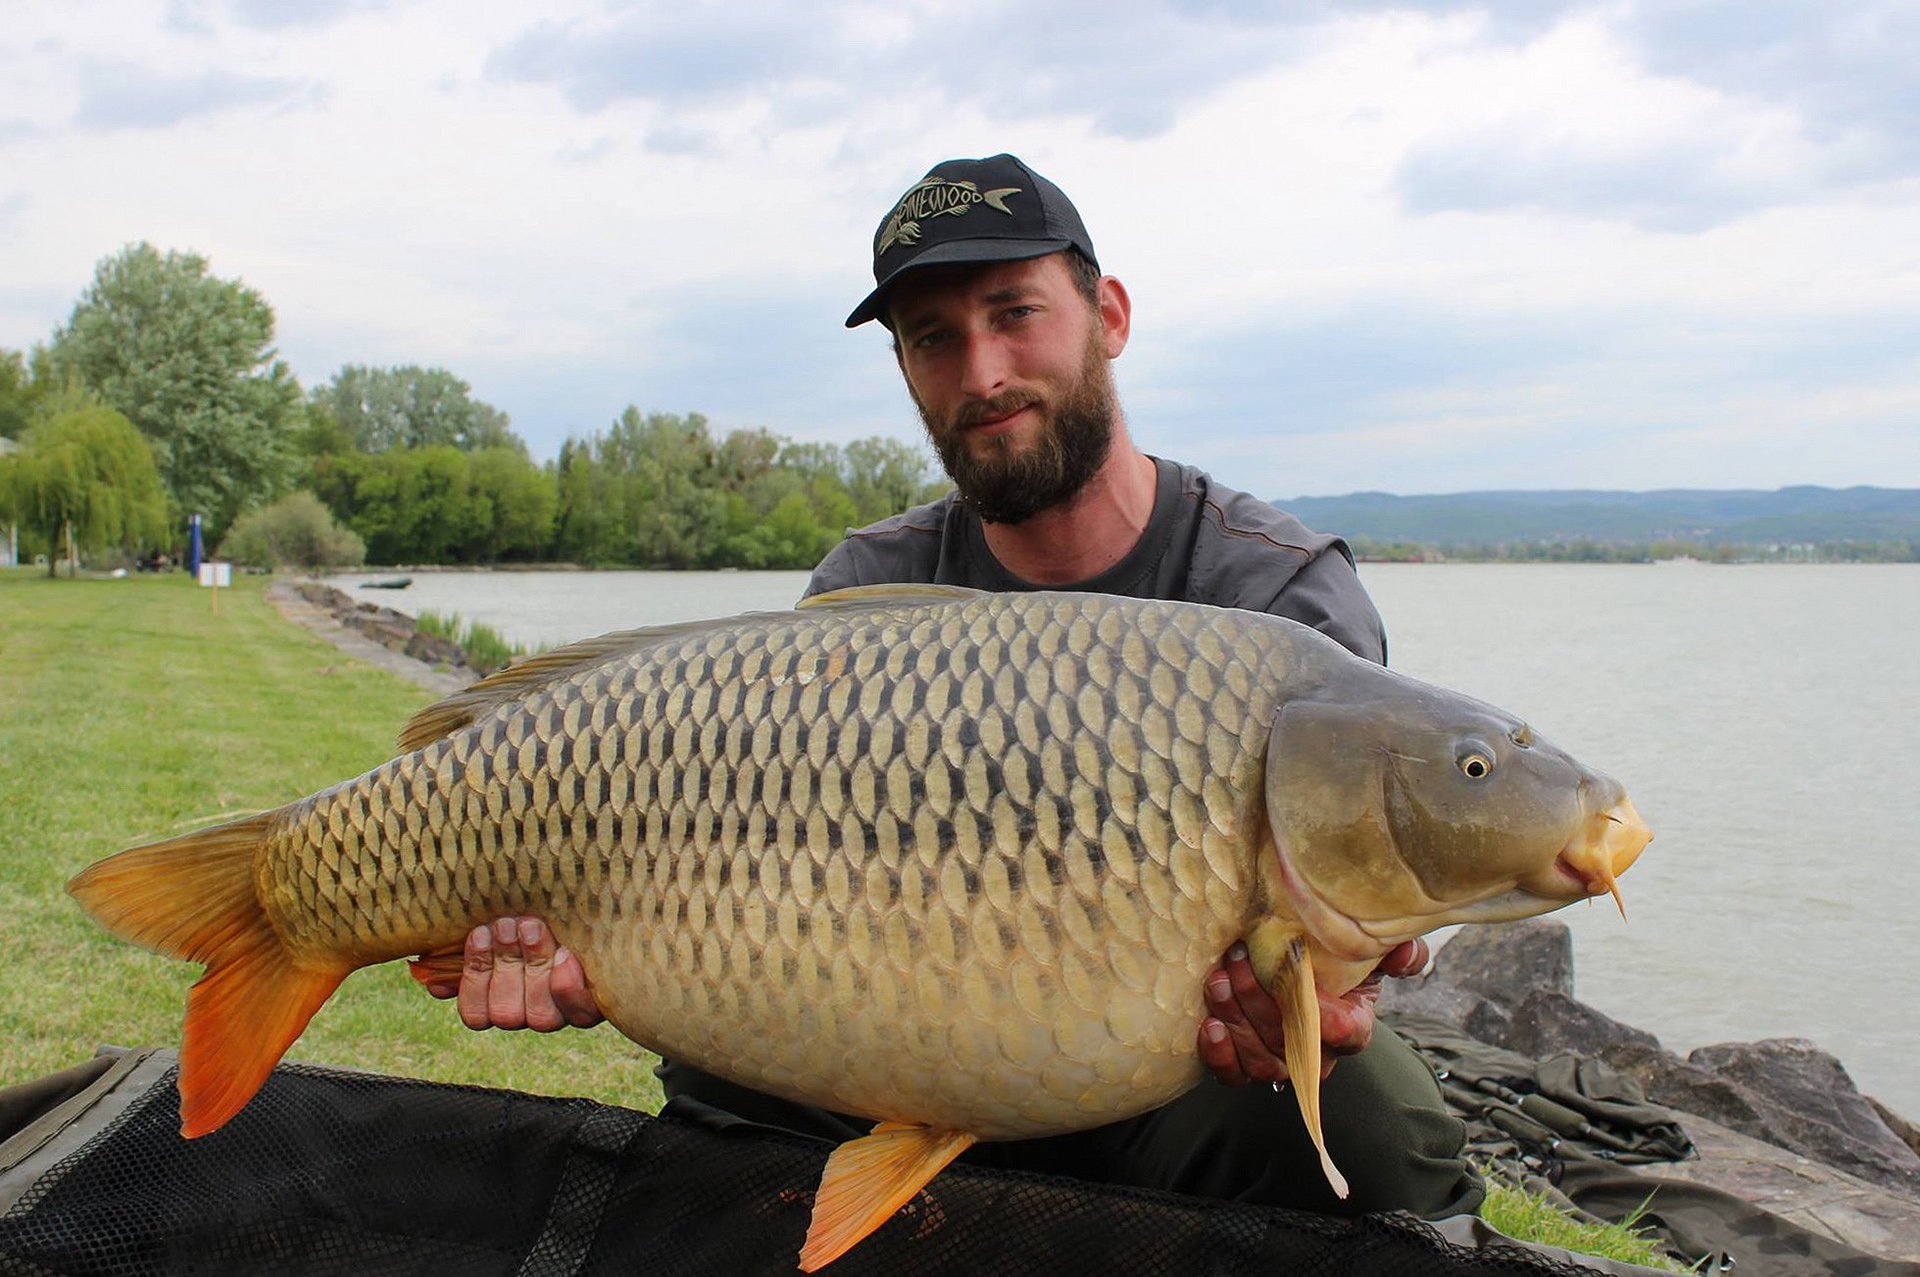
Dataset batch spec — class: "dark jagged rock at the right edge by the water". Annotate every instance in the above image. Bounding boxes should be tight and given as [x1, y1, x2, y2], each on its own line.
[1688, 1037, 1920, 1194]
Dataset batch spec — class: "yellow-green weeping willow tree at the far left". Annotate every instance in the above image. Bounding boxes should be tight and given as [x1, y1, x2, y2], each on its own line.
[0, 394, 167, 576]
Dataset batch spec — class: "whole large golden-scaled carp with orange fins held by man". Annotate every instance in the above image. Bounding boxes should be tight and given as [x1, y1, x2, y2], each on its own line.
[71, 586, 1651, 1269]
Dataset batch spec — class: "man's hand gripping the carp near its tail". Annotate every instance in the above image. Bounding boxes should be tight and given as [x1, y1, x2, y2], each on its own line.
[426, 918, 605, 1033]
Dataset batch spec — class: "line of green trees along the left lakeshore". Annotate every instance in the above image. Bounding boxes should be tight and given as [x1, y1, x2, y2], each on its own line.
[0, 244, 941, 572]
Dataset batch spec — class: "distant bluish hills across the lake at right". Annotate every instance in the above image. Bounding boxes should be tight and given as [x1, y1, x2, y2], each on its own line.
[1275, 486, 1920, 545]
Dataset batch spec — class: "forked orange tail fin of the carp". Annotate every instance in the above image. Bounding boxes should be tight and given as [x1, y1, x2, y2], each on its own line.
[67, 812, 353, 1139]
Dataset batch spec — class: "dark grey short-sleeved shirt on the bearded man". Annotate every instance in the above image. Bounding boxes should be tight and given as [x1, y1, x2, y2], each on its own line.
[806, 457, 1386, 664]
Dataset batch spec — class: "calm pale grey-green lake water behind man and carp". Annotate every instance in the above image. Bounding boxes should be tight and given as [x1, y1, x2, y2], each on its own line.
[322, 565, 1920, 1118]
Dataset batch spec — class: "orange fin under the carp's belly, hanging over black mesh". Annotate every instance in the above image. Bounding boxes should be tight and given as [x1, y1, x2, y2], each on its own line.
[801, 1121, 973, 1273]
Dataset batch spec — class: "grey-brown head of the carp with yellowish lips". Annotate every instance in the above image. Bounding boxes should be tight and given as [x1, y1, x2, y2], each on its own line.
[1265, 663, 1653, 958]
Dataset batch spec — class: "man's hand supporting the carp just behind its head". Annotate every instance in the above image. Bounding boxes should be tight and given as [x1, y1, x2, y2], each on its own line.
[1200, 939, 1430, 1087]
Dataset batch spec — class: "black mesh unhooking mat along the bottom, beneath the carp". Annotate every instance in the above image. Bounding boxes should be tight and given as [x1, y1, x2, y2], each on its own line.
[0, 1052, 1628, 1277]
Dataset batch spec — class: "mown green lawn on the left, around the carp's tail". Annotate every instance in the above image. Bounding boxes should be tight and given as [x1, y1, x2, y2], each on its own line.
[0, 568, 659, 1110]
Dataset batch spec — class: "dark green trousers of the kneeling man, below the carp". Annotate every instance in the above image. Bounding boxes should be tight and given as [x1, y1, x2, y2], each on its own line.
[659, 1025, 1484, 1219]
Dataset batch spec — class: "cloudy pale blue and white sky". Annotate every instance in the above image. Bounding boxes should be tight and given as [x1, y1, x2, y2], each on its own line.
[0, 0, 1920, 497]
